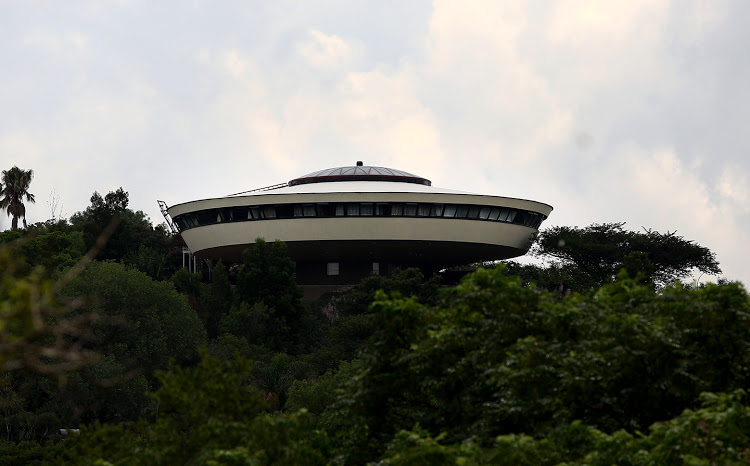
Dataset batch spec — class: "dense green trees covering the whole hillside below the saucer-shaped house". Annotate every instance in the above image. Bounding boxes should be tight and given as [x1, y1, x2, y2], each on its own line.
[0, 177, 750, 465]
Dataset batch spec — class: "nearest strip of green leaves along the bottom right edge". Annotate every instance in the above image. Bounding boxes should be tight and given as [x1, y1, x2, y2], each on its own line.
[374, 390, 750, 466]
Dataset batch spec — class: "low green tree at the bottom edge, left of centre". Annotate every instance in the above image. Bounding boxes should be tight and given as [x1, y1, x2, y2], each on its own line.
[61, 355, 330, 465]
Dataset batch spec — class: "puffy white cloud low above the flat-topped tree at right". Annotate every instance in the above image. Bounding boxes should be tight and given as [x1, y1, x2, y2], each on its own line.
[580, 147, 750, 278]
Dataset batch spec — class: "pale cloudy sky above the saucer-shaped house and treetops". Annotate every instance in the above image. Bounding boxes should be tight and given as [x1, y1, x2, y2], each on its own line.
[0, 0, 750, 283]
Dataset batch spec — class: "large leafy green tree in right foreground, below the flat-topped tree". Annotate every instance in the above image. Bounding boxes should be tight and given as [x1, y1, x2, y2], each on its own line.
[327, 267, 750, 461]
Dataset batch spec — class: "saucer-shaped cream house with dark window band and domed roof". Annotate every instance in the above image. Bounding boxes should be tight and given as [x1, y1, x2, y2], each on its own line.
[166, 162, 552, 292]
